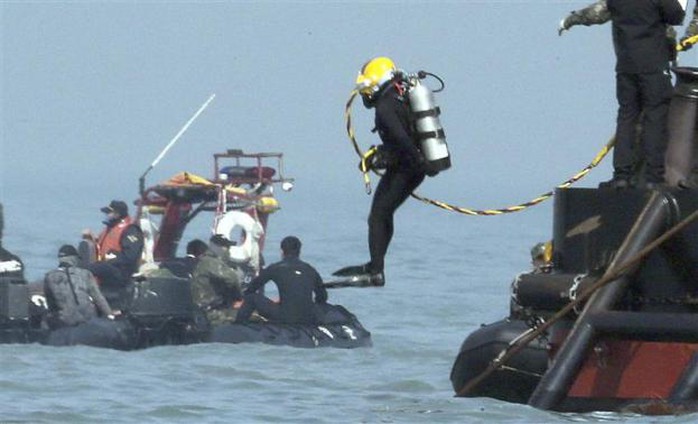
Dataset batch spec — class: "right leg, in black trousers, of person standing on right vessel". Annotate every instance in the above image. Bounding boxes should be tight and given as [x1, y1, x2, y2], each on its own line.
[639, 72, 672, 183]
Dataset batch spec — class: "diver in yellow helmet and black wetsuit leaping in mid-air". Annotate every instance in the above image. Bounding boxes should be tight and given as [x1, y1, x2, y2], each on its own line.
[333, 57, 431, 286]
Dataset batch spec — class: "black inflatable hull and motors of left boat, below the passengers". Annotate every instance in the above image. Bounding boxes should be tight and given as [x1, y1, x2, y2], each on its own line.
[0, 277, 372, 350]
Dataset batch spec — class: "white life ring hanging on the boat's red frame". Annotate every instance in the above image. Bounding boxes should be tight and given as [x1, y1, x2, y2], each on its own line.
[214, 211, 264, 270]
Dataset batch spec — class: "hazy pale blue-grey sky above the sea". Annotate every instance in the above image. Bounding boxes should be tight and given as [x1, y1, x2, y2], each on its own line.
[0, 0, 698, 229]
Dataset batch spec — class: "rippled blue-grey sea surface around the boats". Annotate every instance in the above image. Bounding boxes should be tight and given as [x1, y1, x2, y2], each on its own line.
[0, 183, 698, 423]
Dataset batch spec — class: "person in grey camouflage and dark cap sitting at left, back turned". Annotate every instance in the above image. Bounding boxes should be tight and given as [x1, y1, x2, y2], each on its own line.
[44, 244, 120, 330]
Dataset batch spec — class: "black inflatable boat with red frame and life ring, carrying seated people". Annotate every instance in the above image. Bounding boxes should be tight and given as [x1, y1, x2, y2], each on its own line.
[0, 149, 372, 350]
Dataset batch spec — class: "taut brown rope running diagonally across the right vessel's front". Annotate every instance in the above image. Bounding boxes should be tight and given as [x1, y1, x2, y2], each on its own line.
[456, 205, 698, 397]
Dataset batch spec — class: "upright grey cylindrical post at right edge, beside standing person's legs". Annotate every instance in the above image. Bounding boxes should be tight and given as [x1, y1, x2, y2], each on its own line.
[665, 68, 698, 187]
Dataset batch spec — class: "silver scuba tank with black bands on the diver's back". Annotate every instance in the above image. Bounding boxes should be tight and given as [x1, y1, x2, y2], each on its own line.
[407, 71, 451, 173]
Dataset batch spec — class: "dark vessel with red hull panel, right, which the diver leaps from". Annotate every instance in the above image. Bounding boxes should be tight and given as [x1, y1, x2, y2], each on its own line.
[451, 68, 698, 414]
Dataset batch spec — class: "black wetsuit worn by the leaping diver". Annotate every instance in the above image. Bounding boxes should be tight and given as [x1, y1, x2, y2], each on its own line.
[368, 84, 425, 273]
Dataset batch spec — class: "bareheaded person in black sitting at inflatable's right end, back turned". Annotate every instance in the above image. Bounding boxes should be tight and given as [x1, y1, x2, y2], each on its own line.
[236, 236, 327, 324]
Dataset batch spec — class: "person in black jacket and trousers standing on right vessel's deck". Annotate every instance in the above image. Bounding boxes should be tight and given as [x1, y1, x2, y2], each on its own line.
[560, 0, 686, 189]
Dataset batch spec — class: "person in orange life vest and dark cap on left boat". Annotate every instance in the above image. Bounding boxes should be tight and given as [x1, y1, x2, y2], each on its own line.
[83, 200, 143, 309]
